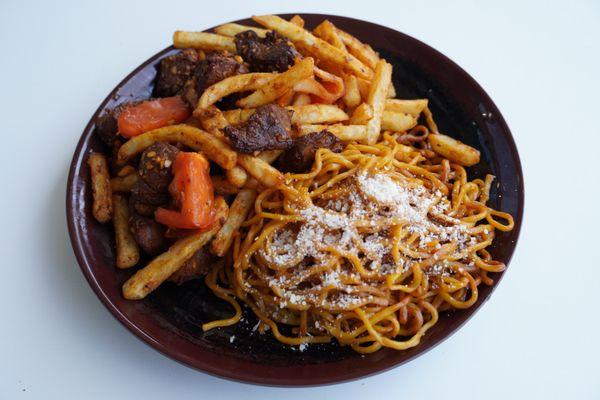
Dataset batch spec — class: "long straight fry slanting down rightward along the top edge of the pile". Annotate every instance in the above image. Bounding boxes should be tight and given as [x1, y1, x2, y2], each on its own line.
[252, 15, 372, 79]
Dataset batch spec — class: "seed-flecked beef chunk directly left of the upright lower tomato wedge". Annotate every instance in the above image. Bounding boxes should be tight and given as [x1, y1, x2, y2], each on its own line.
[138, 142, 179, 192]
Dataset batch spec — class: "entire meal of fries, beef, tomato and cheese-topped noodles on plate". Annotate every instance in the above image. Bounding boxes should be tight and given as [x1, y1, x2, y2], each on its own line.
[87, 15, 514, 353]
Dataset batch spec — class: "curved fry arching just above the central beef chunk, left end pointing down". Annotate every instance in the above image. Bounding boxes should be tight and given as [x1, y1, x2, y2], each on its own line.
[194, 72, 277, 110]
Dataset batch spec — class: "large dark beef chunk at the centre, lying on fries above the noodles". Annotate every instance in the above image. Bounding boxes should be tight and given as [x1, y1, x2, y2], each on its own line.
[224, 104, 292, 153]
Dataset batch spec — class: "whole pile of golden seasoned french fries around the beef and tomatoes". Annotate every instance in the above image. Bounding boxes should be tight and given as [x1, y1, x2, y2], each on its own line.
[88, 15, 479, 299]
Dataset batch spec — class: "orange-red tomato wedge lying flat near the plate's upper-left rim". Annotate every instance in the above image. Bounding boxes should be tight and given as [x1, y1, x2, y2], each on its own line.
[117, 96, 192, 138]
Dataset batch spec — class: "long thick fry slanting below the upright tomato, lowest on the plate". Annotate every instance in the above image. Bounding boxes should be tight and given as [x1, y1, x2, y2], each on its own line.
[123, 197, 228, 300]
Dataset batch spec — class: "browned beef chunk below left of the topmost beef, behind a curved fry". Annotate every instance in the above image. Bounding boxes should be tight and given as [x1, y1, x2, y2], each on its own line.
[194, 53, 248, 96]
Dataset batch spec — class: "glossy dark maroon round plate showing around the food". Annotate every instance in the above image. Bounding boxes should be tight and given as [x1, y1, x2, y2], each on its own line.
[67, 14, 523, 386]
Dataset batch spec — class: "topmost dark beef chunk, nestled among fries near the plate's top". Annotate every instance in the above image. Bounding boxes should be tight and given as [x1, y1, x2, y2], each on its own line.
[235, 31, 298, 72]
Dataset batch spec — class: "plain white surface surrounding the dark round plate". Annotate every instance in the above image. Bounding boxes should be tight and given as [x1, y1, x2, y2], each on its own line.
[0, 0, 600, 400]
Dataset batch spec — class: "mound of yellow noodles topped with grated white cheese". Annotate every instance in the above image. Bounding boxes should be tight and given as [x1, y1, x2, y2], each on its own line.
[203, 126, 513, 353]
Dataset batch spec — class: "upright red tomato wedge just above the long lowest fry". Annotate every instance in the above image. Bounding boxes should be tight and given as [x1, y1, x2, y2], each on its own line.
[154, 151, 215, 230]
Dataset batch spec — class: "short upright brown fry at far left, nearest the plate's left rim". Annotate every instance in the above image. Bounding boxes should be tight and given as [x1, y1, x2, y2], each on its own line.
[87, 153, 113, 223]
